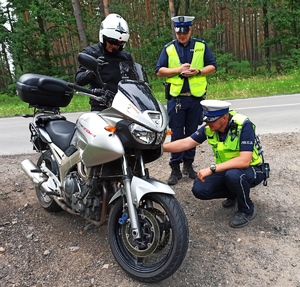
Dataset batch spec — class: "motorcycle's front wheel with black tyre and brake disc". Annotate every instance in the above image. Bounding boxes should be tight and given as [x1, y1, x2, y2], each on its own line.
[108, 193, 189, 283]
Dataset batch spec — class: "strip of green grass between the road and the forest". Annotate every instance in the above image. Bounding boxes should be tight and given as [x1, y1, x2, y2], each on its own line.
[0, 71, 300, 117]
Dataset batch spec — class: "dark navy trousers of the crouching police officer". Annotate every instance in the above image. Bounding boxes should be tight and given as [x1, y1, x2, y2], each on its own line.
[192, 166, 265, 214]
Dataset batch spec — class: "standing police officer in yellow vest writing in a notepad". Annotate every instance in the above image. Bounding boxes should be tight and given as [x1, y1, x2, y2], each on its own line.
[156, 16, 217, 185]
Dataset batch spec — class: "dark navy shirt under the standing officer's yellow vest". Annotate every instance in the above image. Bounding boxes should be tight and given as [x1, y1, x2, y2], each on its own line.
[155, 38, 217, 93]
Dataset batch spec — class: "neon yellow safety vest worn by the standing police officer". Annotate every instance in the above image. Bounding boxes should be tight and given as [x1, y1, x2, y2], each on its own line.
[166, 42, 207, 97]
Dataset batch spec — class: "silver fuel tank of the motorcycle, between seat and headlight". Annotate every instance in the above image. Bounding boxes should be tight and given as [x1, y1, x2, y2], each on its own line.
[71, 112, 124, 167]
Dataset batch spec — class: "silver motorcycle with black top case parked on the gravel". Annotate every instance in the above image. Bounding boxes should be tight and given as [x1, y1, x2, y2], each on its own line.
[17, 53, 189, 283]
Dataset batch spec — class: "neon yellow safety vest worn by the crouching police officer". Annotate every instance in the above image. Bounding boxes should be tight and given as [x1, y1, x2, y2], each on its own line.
[205, 111, 262, 166]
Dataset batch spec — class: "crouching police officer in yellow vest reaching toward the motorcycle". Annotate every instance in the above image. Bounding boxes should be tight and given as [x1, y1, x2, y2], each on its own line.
[163, 100, 266, 228]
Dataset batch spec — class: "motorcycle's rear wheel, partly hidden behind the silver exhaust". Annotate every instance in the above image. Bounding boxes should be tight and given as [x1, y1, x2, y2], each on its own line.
[35, 150, 62, 212]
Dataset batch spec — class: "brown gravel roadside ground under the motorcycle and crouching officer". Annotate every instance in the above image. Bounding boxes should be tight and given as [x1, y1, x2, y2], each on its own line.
[0, 133, 300, 287]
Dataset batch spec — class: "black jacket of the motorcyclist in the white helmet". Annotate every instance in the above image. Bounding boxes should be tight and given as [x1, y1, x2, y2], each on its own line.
[75, 43, 133, 111]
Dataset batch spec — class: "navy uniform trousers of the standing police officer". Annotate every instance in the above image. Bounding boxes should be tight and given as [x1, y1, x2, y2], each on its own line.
[167, 96, 203, 165]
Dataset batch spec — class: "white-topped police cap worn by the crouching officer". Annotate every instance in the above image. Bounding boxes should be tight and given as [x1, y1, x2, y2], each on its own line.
[200, 100, 231, 122]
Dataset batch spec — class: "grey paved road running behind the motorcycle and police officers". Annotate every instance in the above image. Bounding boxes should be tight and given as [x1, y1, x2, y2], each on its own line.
[0, 94, 300, 155]
